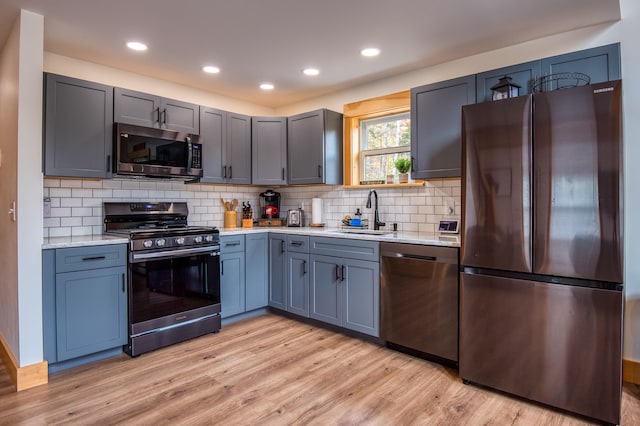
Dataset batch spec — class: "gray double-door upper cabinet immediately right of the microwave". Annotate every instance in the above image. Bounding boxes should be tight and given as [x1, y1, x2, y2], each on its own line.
[200, 107, 251, 184]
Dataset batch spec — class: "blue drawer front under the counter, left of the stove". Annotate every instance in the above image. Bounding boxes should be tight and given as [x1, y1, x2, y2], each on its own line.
[56, 244, 127, 273]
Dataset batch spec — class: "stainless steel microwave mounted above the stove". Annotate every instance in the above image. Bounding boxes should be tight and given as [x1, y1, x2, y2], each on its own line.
[114, 123, 202, 181]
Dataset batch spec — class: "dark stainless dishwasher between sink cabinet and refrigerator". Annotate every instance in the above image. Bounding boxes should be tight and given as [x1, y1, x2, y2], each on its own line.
[380, 243, 458, 363]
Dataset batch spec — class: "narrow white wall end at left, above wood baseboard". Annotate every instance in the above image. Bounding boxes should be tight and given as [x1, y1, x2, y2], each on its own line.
[18, 11, 44, 367]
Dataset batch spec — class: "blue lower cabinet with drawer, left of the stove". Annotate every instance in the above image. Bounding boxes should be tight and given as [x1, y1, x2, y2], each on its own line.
[42, 244, 128, 371]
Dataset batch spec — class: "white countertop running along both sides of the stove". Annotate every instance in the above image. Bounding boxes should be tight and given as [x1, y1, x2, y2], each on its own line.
[42, 226, 460, 250]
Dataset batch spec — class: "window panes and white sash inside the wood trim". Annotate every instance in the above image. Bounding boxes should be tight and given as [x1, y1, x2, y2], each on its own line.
[359, 112, 411, 181]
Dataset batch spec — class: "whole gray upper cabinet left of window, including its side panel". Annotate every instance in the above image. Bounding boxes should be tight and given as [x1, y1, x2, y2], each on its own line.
[287, 109, 343, 185]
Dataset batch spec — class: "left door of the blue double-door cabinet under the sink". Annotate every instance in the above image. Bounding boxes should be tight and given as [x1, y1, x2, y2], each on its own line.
[309, 255, 344, 326]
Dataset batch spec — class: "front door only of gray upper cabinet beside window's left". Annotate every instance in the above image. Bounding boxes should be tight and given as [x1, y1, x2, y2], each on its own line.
[287, 109, 324, 185]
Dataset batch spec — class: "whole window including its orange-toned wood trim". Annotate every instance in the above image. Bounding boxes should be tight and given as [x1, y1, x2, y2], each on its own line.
[344, 90, 422, 187]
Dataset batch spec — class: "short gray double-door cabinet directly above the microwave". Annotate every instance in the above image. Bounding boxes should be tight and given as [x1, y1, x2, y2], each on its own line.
[114, 87, 200, 135]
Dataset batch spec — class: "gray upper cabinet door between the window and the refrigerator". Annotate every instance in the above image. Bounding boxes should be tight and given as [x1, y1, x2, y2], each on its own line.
[411, 75, 476, 179]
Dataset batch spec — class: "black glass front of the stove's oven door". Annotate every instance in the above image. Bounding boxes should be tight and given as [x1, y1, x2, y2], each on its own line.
[130, 254, 220, 323]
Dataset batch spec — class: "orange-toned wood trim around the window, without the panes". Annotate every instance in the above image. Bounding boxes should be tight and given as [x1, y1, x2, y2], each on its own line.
[344, 90, 422, 187]
